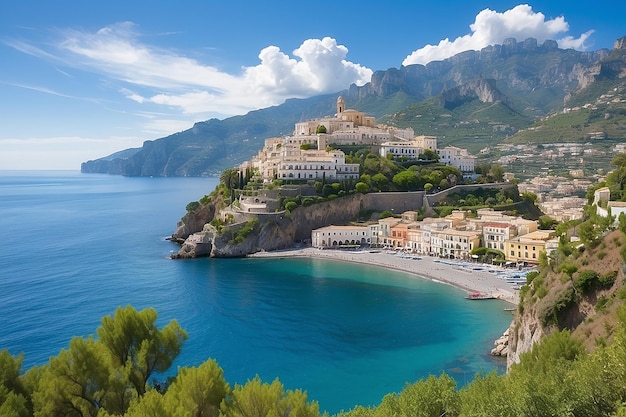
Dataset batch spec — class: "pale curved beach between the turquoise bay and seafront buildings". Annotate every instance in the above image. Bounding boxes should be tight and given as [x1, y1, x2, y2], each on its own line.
[249, 247, 519, 304]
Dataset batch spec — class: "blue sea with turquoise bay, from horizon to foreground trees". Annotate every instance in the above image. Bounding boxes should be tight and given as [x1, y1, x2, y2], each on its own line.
[0, 171, 511, 413]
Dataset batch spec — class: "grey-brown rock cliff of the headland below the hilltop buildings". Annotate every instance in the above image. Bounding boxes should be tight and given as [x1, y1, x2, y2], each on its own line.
[171, 184, 514, 258]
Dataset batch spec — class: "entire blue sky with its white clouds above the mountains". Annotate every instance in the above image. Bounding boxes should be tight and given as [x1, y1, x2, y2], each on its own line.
[0, 0, 626, 170]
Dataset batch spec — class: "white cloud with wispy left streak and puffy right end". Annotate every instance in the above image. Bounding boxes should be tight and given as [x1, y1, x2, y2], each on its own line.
[12, 22, 372, 117]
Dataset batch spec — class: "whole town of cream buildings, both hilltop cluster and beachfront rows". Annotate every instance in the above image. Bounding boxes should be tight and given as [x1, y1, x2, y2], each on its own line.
[230, 96, 591, 266]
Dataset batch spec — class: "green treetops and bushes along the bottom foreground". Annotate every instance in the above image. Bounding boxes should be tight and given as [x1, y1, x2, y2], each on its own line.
[6, 300, 626, 417]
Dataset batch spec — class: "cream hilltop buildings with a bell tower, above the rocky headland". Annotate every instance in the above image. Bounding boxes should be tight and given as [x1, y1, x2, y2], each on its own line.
[239, 96, 475, 183]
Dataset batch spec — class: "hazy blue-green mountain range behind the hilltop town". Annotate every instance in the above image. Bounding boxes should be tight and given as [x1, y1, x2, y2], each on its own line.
[81, 39, 622, 176]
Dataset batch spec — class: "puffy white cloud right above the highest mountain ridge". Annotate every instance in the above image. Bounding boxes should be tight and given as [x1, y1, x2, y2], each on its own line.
[402, 4, 593, 66]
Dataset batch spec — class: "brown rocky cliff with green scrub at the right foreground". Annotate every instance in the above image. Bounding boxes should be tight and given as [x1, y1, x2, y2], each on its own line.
[507, 231, 626, 367]
